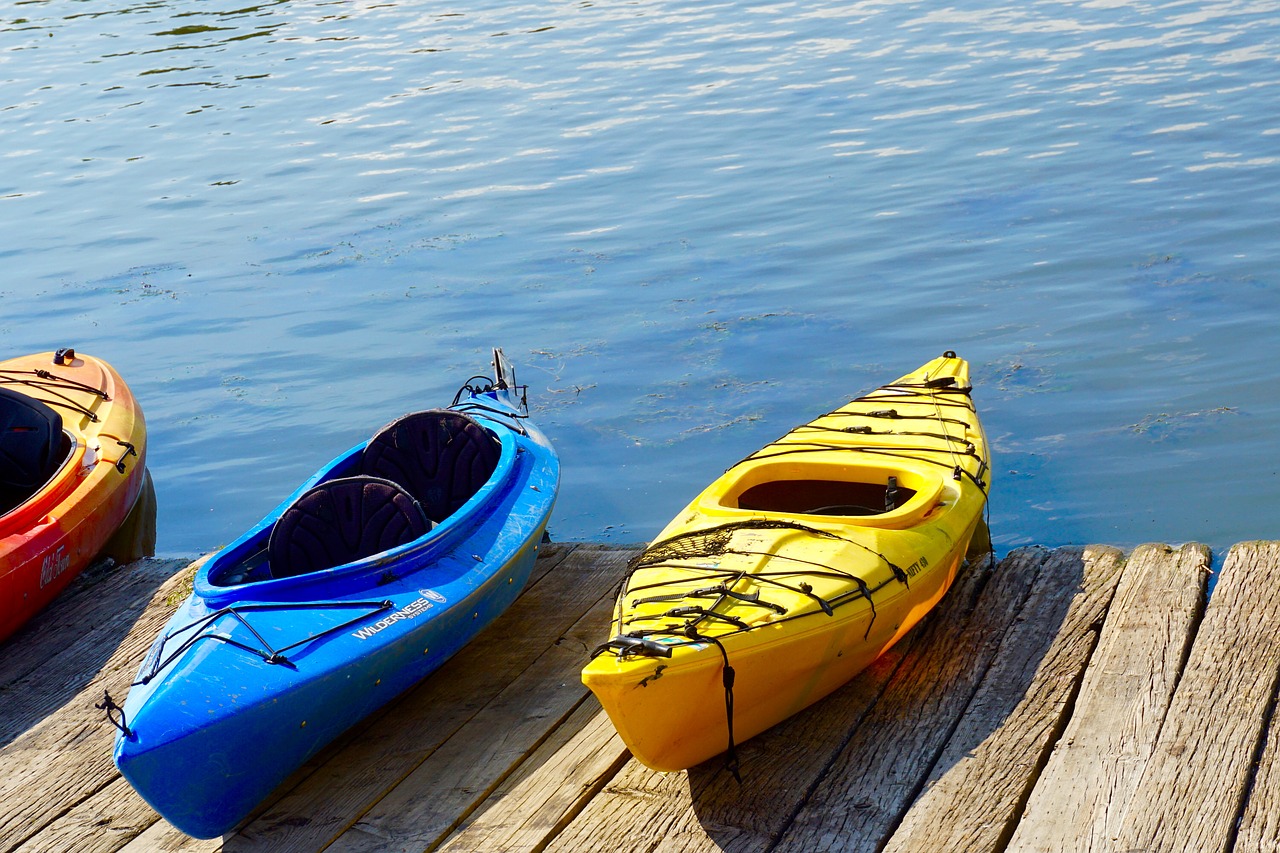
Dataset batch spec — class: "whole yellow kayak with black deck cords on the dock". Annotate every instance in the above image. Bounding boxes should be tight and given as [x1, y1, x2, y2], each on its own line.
[582, 352, 991, 772]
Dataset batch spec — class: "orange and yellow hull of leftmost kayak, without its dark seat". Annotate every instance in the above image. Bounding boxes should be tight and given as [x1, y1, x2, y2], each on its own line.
[0, 352, 147, 640]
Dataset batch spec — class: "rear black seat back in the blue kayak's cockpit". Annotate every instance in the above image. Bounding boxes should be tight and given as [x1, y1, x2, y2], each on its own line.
[360, 409, 502, 523]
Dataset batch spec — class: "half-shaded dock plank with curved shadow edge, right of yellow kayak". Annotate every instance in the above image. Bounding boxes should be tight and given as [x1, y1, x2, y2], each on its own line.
[884, 547, 1124, 852]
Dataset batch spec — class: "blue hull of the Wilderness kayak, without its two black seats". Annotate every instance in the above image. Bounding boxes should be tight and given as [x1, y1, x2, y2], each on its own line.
[113, 348, 559, 838]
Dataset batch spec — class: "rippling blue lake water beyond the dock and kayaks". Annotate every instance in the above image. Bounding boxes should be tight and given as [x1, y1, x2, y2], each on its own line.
[0, 0, 1280, 556]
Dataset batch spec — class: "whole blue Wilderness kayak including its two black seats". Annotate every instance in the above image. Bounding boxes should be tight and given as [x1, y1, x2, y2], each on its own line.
[112, 350, 559, 838]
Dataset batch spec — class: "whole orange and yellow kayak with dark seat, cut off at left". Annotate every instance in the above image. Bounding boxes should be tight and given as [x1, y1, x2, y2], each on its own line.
[0, 350, 147, 640]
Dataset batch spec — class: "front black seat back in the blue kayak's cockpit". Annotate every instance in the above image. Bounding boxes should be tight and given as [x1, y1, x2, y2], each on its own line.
[266, 476, 431, 578]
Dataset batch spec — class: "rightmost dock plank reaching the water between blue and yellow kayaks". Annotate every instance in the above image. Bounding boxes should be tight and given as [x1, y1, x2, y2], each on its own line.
[335, 552, 630, 853]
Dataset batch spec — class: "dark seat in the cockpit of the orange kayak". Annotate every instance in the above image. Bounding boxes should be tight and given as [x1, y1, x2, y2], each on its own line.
[0, 388, 65, 512]
